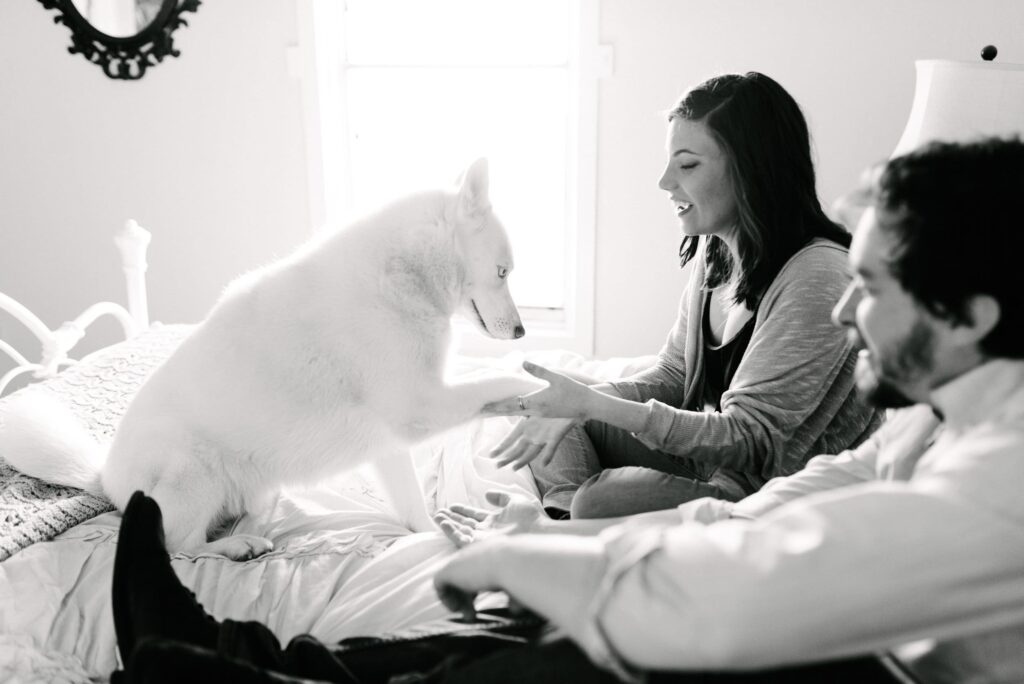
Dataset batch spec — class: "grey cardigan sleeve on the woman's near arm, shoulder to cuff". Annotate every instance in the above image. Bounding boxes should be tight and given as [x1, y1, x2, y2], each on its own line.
[618, 245, 873, 479]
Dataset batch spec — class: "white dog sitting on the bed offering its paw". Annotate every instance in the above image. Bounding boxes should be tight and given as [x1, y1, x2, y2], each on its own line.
[0, 160, 542, 559]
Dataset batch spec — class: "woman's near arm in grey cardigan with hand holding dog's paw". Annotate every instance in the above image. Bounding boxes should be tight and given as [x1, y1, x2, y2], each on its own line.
[485, 245, 871, 479]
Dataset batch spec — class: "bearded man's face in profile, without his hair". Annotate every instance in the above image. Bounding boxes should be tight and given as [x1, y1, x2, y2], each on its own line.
[833, 208, 940, 408]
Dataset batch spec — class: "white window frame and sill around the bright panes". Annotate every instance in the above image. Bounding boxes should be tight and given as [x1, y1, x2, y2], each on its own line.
[290, 0, 598, 357]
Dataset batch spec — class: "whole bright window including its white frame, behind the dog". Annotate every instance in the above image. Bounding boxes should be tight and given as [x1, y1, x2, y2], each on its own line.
[300, 0, 597, 354]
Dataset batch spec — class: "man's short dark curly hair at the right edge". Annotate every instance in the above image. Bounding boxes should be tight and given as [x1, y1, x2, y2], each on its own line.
[873, 138, 1024, 358]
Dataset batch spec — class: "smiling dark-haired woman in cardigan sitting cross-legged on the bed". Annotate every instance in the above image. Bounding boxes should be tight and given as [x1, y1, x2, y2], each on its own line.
[487, 72, 881, 517]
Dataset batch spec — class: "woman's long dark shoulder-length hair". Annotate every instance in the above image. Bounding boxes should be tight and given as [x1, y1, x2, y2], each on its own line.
[669, 72, 850, 308]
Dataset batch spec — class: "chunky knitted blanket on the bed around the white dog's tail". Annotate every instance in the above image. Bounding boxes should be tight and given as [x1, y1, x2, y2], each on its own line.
[0, 326, 191, 560]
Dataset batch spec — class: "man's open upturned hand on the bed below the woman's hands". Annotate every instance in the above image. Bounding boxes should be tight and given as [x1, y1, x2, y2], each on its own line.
[434, 489, 546, 549]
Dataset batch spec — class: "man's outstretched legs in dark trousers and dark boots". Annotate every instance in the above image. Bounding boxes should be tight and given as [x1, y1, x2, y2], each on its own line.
[112, 493, 901, 684]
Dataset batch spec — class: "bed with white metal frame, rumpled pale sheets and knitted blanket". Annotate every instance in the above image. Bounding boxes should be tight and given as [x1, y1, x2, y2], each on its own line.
[0, 221, 650, 682]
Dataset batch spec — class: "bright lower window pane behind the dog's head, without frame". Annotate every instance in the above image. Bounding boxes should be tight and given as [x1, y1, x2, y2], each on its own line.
[348, 67, 566, 308]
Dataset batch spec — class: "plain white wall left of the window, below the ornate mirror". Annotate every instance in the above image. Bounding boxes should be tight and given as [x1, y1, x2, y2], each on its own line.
[0, 0, 309, 352]
